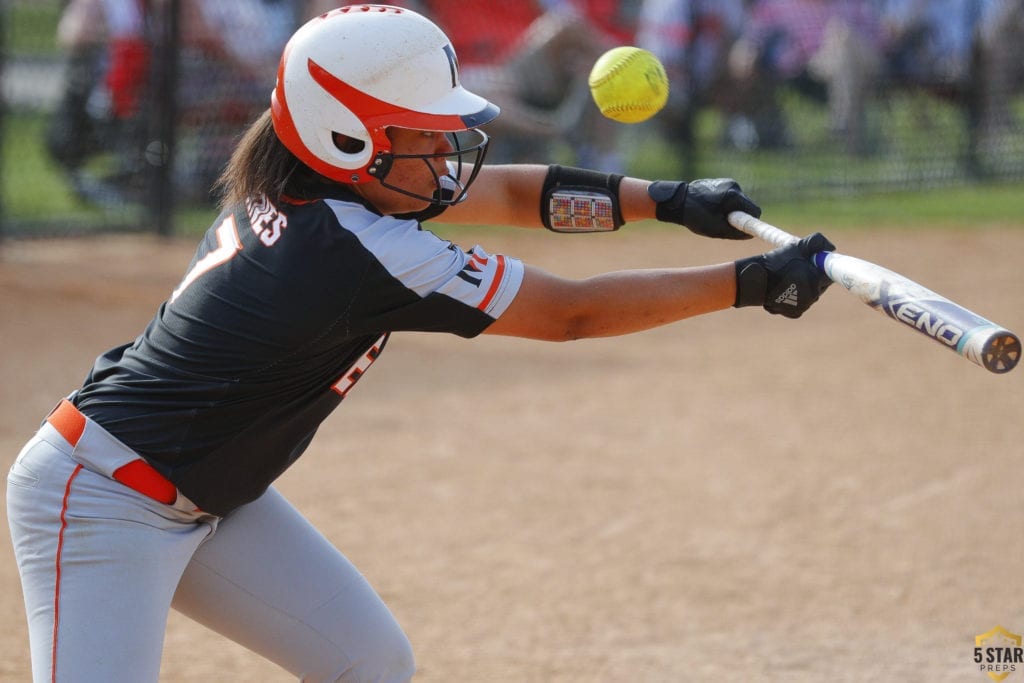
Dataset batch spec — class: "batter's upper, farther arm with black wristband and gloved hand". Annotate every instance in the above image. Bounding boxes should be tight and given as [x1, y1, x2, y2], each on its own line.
[441, 164, 761, 240]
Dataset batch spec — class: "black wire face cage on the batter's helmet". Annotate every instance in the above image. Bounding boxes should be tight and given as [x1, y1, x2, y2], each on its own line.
[373, 128, 490, 206]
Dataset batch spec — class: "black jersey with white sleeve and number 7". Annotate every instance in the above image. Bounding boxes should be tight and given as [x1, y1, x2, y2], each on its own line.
[73, 186, 523, 516]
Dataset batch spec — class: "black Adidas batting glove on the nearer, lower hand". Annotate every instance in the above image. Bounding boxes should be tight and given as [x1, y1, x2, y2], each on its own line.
[733, 232, 836, 317]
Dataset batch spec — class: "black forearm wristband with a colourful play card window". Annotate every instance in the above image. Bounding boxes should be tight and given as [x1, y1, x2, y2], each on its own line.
[541, 164, 625, 232]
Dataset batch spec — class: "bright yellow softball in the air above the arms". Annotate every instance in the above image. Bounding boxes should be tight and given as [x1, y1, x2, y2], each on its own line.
[588, 46, 669, 123]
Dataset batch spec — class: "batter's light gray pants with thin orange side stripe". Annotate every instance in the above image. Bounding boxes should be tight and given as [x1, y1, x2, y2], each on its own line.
[7, 405, 415, 683]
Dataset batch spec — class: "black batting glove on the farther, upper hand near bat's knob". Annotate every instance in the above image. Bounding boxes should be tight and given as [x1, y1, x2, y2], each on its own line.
[647, 178, 761, 240]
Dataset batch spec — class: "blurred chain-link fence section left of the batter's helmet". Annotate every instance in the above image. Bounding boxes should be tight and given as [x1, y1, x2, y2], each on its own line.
[0, 0, 304, 237]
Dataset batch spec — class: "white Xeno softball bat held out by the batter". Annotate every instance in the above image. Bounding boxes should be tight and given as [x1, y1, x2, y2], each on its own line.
[729, 211, 1021, 374]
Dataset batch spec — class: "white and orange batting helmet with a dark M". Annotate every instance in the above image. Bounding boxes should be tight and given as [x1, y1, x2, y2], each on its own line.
[270, 5, 499, 204]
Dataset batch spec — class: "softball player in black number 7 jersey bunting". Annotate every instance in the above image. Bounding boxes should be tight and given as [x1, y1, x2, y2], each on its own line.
[7, 5, 831, 683]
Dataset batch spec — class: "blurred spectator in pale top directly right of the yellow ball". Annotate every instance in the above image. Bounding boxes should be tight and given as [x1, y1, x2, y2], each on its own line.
[636, 0, 746, 163]
